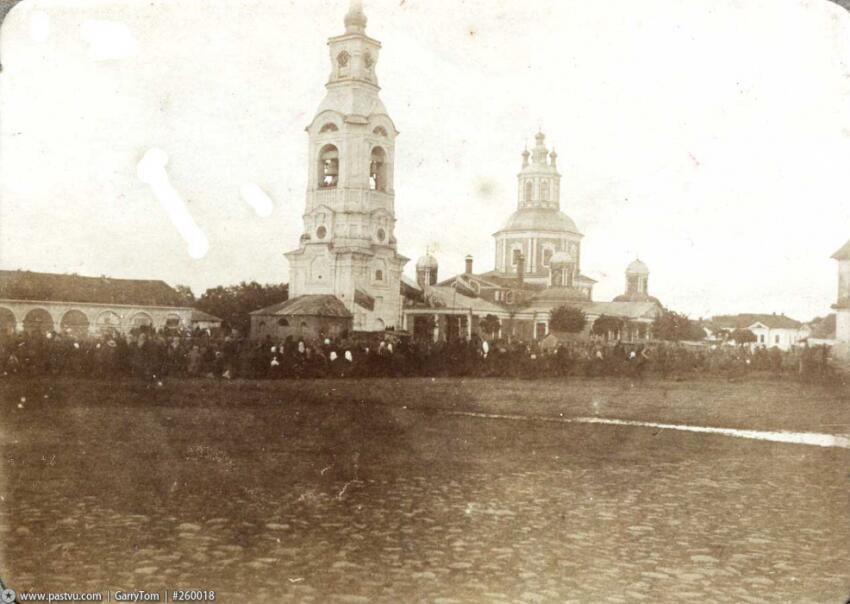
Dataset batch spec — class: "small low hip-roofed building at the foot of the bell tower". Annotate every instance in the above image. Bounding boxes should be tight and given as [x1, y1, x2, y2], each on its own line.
[251, 294, 353, 341]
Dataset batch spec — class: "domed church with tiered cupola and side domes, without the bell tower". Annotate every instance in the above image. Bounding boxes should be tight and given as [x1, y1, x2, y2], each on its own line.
[404, 132, 662, 340]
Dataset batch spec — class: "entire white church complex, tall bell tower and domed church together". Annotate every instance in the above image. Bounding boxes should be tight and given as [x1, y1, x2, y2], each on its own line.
[251, 0, 661, 340]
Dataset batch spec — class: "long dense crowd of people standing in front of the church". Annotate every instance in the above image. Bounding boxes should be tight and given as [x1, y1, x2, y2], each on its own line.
[0, 329, 829, 380]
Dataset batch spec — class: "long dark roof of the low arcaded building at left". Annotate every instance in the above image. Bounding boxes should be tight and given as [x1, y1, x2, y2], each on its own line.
[0, 270, 187, 307]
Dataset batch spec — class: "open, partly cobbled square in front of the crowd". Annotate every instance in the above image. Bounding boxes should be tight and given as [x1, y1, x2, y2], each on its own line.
[0, 379, 850, 602]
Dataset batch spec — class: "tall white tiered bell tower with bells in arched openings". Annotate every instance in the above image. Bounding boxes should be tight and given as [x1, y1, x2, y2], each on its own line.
[286, 0, 408, 331]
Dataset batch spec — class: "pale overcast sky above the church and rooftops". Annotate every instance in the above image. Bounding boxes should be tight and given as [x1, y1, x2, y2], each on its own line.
[0, 0, 850, 320]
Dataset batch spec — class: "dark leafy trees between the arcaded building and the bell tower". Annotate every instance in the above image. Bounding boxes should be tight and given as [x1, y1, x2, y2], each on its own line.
[195, 281, 289, 333]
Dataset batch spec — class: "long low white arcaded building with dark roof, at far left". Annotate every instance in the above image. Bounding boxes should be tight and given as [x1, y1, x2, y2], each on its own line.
[0, 271, 192, 337]
